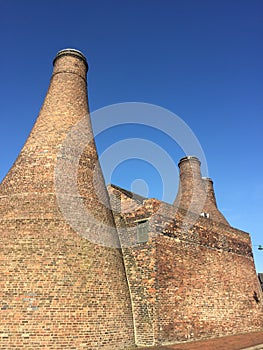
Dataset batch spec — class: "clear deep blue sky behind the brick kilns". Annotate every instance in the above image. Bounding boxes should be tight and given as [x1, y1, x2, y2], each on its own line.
[0, 0, 263, 272]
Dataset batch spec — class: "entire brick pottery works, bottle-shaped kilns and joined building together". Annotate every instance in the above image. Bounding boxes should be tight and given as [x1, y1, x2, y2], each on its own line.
[0, 49, 263, 350]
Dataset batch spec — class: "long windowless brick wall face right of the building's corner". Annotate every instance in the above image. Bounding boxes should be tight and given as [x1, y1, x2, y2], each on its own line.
[156, 215, 263, 342]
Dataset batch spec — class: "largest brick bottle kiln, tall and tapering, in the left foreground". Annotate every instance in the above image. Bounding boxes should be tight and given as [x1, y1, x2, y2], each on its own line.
[0, 50, 134, 350]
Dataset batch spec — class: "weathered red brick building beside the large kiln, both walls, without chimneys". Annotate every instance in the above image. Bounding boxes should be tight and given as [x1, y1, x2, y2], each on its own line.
[109, 188, 263, 346]
